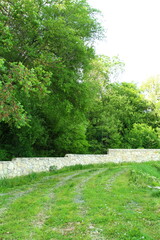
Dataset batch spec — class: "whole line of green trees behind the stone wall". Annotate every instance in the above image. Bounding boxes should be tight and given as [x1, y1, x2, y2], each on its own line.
[0, 0, 160, 160]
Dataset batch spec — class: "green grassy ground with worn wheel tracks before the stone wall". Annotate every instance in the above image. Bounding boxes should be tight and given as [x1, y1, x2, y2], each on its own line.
[0, 162, 160, 240]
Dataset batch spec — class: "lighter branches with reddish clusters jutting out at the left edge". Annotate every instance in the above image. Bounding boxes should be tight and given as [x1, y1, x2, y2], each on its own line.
[0, 58, 51, 127]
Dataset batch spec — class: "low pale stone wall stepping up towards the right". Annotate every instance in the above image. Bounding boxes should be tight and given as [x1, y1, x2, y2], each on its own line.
[0, 149, 160, 178]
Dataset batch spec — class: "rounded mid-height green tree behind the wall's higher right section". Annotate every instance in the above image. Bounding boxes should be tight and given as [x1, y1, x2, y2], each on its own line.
[88, 83, 159, 152]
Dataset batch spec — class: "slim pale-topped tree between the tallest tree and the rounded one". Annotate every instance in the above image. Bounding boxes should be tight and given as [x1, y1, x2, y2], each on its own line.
[84, 55, 124, 153]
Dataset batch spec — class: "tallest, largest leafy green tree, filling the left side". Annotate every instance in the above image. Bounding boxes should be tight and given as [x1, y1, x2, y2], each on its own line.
[0, 0, 103, 159]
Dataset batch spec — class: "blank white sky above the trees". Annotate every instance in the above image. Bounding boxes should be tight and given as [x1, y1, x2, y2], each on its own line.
[88, 0, 160, 85]
